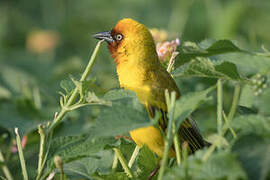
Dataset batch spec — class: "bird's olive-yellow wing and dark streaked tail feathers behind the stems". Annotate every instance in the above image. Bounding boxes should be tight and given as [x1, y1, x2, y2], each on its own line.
[145, 68, 206, 152]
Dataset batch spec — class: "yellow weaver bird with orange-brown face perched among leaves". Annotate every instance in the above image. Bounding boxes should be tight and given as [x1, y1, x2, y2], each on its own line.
[94, 19, 207, 157]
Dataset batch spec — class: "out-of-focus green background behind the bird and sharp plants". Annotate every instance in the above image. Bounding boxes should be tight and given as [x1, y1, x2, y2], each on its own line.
[0, 0, 270, 177]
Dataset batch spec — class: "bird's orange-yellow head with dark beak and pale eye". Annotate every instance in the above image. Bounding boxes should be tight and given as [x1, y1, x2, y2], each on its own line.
[94, 19, 157, 64]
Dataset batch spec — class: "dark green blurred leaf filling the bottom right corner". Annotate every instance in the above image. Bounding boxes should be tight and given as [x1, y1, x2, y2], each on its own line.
[232, 133, 270, 180]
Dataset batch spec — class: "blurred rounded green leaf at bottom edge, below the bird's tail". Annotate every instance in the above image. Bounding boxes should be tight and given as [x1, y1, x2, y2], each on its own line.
[164, 151, 246, 180]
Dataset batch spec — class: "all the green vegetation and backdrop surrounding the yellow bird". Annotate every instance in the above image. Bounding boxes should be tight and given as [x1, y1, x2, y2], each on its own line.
[0, 0, 270, 180]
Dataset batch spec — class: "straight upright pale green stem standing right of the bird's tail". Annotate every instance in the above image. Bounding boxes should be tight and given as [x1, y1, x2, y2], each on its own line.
[217, 79, 223, 135]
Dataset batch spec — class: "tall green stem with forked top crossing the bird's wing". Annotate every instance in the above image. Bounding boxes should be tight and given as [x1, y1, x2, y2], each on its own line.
[158, 91, 176, 180]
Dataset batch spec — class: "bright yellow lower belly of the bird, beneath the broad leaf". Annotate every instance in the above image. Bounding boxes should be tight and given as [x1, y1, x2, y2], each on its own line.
[129, 126, 175, 157]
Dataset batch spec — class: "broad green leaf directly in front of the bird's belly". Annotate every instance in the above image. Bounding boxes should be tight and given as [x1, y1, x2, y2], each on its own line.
[93, 98, 153, 136]
